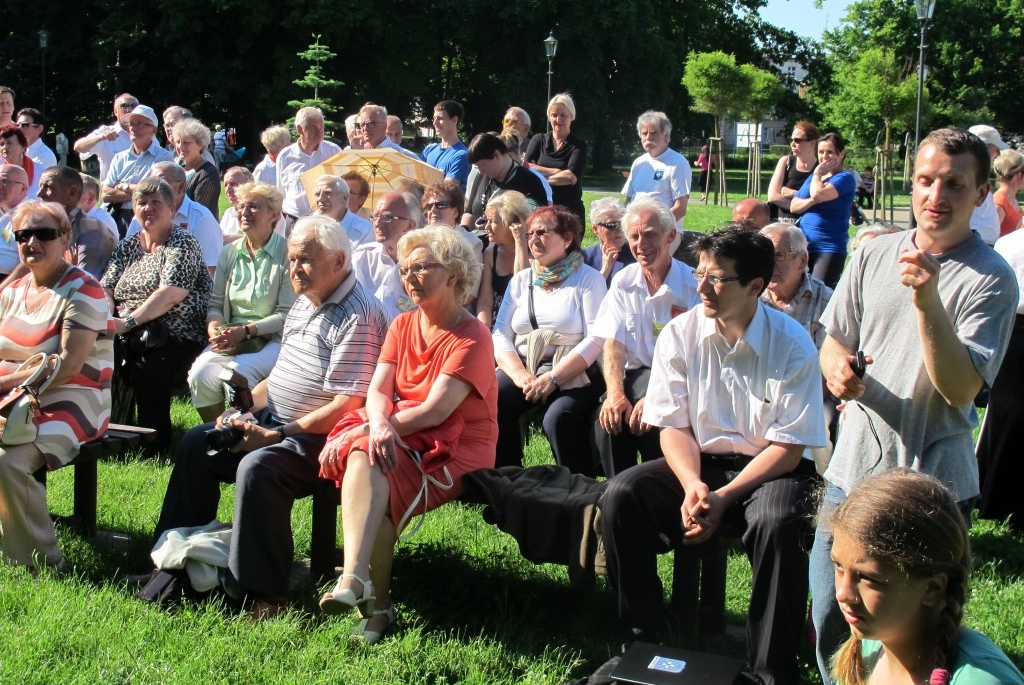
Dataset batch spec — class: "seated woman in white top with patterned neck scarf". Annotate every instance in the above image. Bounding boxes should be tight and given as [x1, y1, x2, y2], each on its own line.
[494, 205, 608, 475]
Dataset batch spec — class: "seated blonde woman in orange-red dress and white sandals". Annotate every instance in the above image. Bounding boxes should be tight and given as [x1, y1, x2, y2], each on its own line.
[319, 225, 498, 644]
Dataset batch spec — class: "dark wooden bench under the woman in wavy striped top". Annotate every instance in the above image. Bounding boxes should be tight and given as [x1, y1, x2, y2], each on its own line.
[35, 424, 157, 538]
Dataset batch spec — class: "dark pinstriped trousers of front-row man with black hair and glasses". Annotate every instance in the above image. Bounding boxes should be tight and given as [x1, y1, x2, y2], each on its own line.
[599, 455, 816, 685]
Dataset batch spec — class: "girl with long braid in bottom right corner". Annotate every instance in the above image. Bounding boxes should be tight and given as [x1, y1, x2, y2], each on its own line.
[821, 469, 1024, 685]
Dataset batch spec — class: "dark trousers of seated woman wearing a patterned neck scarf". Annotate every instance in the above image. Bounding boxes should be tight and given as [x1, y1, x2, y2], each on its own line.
[495, 370, 602, 476]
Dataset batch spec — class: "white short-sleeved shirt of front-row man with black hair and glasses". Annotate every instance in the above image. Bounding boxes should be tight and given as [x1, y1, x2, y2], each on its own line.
[643, 301, 825, 459]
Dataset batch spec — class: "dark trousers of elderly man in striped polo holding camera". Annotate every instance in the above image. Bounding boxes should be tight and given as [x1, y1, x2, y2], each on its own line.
[157, 412, 327, 598]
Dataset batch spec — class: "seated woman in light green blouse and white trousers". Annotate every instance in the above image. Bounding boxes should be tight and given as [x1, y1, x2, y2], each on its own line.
[188, 183, 295, 422]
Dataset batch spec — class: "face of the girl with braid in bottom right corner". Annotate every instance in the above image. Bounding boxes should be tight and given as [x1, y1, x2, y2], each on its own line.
[831, 531, 937, 644]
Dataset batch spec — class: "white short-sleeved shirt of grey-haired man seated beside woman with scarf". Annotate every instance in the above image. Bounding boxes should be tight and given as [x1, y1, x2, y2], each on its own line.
[591, 259, 700, 370]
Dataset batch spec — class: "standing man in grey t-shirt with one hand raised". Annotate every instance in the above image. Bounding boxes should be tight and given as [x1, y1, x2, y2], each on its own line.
[811, 129, 1017, 683]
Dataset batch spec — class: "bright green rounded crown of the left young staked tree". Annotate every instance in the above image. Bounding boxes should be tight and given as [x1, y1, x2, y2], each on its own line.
[683, 50, 751, 137]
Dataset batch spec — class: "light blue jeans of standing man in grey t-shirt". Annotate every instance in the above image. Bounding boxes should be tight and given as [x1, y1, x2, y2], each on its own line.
[809, 483, 850, 685]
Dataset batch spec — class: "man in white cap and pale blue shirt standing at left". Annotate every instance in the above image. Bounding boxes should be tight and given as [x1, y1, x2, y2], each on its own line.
[102, 104, 174, 233]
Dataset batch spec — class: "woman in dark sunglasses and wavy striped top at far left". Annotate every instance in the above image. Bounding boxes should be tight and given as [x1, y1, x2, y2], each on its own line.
[0, 201, 114, 568]
